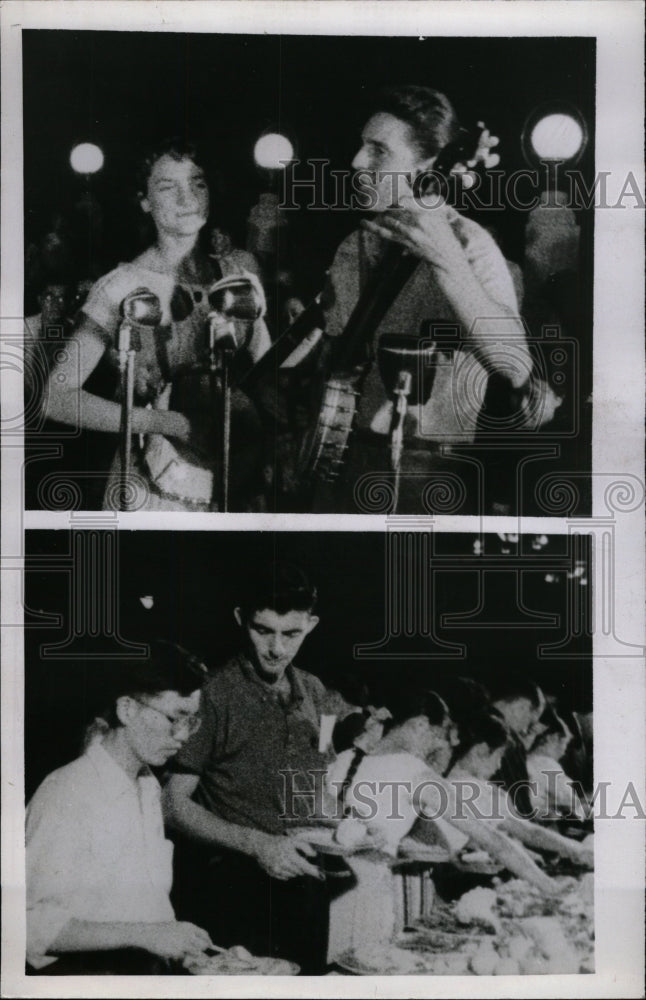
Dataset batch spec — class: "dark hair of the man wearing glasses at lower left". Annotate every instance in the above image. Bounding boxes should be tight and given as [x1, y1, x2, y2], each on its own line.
[100, 639, 208, 729]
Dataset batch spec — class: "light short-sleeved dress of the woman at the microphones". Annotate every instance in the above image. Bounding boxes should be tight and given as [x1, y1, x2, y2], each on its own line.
[83, 250, 271, 511]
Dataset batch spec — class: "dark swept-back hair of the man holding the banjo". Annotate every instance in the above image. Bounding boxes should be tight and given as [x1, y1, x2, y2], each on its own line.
[366, 84, 460, 158]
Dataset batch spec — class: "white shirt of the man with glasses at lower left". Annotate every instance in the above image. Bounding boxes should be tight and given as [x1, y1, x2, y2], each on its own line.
[26, 741, 175, 968]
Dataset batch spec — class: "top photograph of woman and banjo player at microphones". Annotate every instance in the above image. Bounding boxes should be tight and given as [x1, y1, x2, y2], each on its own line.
[22, 31, 596, 517]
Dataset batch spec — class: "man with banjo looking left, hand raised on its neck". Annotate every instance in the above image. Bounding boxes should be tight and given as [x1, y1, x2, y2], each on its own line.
[294, 86, 552, 513]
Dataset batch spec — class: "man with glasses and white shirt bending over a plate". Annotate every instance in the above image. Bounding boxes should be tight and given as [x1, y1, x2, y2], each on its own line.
[26, 642, 211, 975]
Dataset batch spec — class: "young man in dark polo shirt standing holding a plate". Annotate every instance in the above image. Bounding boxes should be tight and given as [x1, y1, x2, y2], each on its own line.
[165, 564, 352, 975]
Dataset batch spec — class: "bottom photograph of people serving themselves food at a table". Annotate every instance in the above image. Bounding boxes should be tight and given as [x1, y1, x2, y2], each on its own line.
[25, 527, 594, 976]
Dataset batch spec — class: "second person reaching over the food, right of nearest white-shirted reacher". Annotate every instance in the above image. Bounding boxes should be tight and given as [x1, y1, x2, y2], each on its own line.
[447, 713, 594, 868]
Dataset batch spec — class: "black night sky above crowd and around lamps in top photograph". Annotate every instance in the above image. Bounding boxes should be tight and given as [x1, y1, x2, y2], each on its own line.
[23, 30, 595, 294]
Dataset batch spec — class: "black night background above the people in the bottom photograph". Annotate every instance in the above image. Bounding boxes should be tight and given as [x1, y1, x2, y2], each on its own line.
[25, 531, 592, 795]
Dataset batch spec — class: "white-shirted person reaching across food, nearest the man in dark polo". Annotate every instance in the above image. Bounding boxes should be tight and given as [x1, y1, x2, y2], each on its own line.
[327, 691, 562, 894]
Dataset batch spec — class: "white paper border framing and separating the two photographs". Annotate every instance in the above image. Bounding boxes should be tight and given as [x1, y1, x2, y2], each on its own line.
[0, 0, 646, 998]
